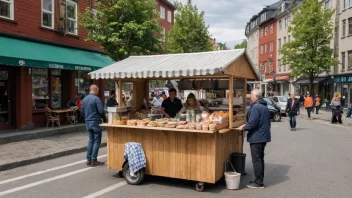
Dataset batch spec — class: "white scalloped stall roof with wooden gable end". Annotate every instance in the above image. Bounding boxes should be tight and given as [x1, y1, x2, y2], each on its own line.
[90, 49, 259, 79]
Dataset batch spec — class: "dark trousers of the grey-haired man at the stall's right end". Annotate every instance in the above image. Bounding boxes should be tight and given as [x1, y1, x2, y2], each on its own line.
[250, 142, 266, 185]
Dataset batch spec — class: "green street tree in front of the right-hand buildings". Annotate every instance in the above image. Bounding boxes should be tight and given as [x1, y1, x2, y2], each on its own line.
[280, 0, 336, 92]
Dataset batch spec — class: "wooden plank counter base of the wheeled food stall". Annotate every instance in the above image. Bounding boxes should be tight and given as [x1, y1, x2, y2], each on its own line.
[101, 124, 243, 184]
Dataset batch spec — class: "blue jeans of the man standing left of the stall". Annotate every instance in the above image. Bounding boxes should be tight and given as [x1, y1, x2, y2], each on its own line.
[86, 121, 101, 161]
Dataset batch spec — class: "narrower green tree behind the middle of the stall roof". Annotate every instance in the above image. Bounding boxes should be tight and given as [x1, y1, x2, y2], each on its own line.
[166, 0, 214, 53]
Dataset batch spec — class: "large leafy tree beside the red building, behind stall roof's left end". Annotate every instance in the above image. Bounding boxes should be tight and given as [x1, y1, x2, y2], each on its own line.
[80, 0, 161, 61]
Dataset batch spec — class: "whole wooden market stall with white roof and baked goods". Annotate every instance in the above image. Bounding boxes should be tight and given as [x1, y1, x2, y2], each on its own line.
[90, 49, 258, 191]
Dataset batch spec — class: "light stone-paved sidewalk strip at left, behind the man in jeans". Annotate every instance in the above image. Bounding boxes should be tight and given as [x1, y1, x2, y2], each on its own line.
[0, 131, 106, 171]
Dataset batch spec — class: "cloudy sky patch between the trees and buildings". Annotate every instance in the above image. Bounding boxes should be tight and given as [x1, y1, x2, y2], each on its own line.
[179, 0, 276, 48]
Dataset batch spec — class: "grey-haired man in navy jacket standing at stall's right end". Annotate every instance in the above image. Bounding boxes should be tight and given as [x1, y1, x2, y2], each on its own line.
[240, 89, 271, 188]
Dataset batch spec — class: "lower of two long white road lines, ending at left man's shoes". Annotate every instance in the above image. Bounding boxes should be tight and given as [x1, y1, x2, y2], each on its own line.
[0, 167, 94, 197]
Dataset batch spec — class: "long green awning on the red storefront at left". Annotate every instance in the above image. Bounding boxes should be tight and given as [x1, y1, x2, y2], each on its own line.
[0, 36, 115, 71]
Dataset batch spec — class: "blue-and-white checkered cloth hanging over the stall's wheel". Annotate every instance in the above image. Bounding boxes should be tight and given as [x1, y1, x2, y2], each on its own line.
[124, 142, 147, 174]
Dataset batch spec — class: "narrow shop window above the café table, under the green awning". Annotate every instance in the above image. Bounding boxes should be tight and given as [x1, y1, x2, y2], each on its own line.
[51, 69, 63, 109]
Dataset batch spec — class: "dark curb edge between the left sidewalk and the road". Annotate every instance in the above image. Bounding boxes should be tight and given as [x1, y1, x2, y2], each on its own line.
[0, 142, 107, 171]
